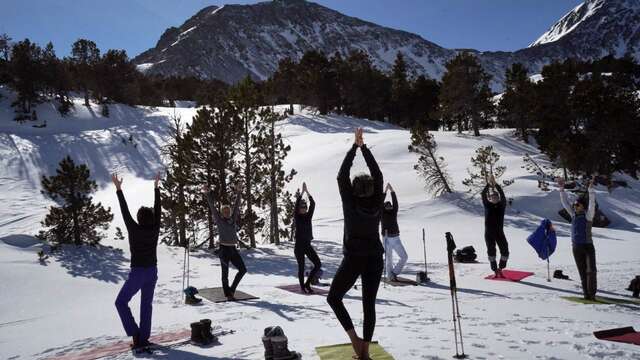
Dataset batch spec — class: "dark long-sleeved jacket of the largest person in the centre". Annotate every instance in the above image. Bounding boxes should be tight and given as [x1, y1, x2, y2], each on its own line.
[338, 144, 384, 256]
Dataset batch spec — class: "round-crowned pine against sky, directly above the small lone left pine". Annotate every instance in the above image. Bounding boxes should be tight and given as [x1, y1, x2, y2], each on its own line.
[71, 39, 100, 107]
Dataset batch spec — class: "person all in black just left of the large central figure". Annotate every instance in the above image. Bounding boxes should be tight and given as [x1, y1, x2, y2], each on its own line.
[293, 183, 322, 294]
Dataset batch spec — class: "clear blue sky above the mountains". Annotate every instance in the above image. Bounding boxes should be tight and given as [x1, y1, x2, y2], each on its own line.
[0, 0, 582, 57]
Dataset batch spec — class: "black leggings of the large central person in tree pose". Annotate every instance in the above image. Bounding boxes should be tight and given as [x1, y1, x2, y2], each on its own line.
[327, 254, 384, 341]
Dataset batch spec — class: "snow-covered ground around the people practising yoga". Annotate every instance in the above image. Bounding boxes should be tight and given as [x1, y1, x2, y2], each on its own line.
[0, 89, 640, 359]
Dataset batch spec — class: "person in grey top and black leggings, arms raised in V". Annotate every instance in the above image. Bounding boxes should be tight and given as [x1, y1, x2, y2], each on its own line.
[202, 184, 247, 301]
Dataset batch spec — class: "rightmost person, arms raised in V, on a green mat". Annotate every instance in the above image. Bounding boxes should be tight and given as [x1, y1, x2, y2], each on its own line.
[558, 179, 598, 300]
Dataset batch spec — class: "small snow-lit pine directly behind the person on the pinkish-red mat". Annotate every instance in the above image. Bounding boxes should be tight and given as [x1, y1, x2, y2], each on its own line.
[462, 145, 508, 193]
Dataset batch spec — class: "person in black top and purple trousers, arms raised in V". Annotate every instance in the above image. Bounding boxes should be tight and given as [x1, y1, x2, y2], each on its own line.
[111, 174, 161, 349]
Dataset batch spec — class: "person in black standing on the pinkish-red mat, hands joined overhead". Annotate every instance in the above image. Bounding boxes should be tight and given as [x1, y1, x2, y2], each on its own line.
[482, 175, 509, 277]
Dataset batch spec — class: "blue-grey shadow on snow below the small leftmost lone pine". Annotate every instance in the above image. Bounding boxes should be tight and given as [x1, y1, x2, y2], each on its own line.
[50, 245, 129, 283]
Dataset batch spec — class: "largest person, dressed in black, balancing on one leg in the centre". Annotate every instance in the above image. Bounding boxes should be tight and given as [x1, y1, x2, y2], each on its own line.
[327, 128, 384, 359]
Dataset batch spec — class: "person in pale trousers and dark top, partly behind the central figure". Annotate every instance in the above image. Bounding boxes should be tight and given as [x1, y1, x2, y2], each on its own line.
[382, 184, 407, 281]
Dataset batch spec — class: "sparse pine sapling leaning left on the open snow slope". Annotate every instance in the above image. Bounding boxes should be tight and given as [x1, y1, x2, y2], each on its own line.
[409, 126, 453, 196]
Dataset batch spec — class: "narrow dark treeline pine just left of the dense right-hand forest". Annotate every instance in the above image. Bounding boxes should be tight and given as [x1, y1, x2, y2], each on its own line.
[497, 63, 536, 143]
